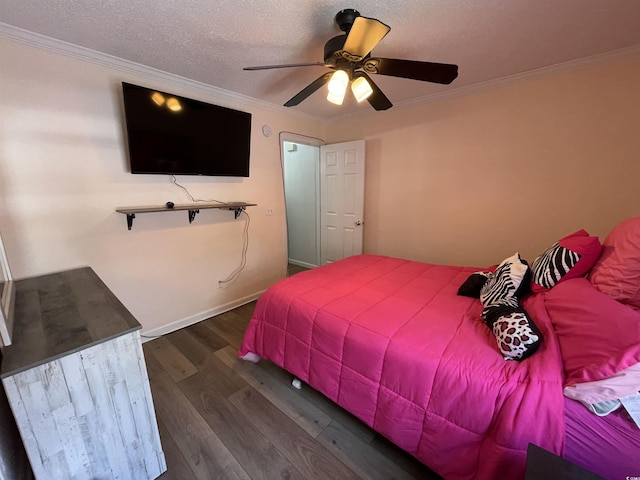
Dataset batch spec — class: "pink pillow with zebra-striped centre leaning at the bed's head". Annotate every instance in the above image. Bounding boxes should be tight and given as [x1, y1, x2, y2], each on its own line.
[531, 230, 602, 292]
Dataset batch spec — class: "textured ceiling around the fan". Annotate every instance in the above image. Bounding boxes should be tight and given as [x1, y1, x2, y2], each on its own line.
[0, 0, 640, 118]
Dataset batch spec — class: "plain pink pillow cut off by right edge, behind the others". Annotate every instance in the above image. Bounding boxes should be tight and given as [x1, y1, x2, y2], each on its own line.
[589, 217, 640, 309]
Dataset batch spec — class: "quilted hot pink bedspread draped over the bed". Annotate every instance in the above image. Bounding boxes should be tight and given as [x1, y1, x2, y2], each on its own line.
[239, 255, 565, 480]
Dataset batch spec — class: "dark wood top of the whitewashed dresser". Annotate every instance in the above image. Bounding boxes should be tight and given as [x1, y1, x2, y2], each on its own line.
[0, 267, 141, 378]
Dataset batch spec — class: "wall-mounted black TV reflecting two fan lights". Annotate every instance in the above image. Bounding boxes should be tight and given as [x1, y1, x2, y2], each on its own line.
[122, 82, 251, 177]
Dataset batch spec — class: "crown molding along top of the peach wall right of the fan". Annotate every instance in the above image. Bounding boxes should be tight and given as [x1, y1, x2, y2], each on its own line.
[331, 45, 640, 121]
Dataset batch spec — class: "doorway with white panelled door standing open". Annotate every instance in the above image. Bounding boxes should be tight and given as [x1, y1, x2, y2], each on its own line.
[281, 134, 365, 268]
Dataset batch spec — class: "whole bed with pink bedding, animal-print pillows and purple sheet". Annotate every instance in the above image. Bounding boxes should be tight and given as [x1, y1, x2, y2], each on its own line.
[239, 217, 640, 480]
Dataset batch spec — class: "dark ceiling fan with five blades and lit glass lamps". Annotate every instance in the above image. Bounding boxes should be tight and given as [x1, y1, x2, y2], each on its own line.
[244, 8, 458, 110]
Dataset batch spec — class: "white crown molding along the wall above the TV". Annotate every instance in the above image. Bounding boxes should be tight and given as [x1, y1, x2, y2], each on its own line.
[0, 22, 326, 124]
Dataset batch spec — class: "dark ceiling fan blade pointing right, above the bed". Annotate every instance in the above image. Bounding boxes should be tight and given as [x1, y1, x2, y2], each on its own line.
[362, 58, 458, 85]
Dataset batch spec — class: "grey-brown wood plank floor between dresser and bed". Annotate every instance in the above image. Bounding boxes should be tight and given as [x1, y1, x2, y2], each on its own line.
[143, 292, 440, 480]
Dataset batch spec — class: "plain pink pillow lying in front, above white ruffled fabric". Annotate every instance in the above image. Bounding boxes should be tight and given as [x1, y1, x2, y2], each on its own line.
[544, 278, 640, 385]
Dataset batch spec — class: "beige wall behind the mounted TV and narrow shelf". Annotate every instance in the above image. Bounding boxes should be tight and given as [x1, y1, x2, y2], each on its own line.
[0, 39, 324, 333]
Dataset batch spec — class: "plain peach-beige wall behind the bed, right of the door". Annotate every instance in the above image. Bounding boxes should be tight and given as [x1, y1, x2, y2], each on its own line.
[327, 54, 640, 266]
